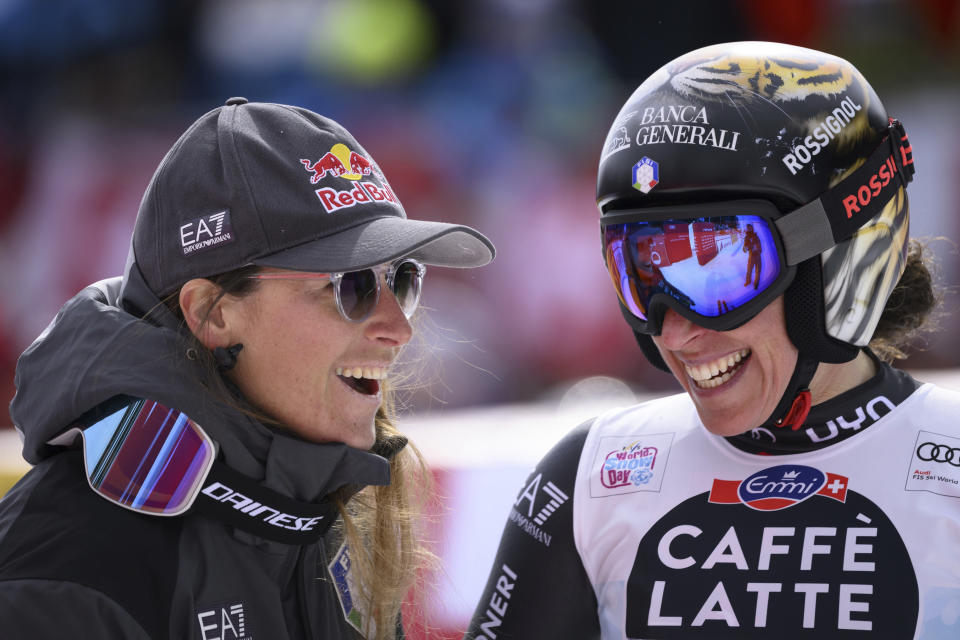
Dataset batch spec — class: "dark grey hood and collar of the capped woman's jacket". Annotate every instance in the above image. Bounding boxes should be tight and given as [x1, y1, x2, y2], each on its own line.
[10, 278, 394, 502]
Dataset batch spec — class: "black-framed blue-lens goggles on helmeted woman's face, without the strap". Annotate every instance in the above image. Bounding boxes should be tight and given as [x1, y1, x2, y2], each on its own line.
[602, 200, 796, 334]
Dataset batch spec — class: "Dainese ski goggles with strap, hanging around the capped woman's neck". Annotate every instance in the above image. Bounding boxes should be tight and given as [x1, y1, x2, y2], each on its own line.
[48, 396, 337, 543]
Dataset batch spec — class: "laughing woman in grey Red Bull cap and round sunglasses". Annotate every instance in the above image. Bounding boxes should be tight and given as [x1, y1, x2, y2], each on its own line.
[0, 98, 493, 640]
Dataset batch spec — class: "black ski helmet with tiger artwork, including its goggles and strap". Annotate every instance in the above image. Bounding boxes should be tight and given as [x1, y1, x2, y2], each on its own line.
[597, 42, 914, 369]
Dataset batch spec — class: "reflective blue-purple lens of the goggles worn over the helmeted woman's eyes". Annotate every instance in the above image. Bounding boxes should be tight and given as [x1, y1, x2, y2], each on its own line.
[603, 215, 781, 321]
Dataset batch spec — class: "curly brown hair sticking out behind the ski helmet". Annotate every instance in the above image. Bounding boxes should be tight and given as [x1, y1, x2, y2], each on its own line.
[870, 238, 943, 362]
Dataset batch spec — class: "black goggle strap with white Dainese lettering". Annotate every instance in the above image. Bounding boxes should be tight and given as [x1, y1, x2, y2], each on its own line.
[193, 460, 338, 545]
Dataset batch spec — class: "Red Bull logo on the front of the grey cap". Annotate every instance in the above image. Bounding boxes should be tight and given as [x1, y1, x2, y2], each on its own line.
[300, 143, 400, 213]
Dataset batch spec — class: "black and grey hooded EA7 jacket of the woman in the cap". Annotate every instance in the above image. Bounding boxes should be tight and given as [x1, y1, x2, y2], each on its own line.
[0, 276, 398, 640]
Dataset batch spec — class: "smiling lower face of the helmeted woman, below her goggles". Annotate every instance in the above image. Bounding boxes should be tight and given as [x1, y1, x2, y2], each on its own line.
[653, 296, 797, 436]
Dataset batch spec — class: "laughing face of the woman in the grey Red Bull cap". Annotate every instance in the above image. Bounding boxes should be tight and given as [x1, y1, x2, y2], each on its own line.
[218, 269, 412, 449]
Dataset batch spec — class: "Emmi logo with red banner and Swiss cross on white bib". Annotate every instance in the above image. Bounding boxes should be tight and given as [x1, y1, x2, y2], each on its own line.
[708, 464, 847, 511]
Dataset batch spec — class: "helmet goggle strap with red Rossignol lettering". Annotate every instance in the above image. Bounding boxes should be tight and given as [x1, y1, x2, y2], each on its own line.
[774, 118, 916, 265]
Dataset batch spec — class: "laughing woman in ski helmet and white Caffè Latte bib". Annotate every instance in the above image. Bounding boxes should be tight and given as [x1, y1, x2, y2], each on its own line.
[468, 42, 960, 639]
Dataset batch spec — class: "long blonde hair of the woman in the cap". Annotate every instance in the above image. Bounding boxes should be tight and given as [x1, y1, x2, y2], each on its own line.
[164, 267, 438, 640]
